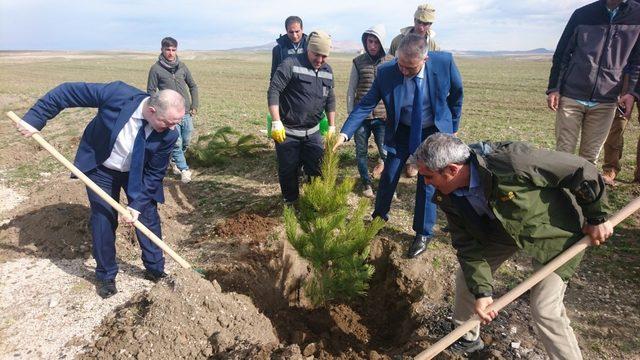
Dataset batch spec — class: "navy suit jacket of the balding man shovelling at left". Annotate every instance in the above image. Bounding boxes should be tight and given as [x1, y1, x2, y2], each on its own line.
[24, 81, 178, 211]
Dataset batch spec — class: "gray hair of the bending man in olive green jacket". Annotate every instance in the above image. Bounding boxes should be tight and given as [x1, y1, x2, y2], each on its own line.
[415, 133, 471, 171]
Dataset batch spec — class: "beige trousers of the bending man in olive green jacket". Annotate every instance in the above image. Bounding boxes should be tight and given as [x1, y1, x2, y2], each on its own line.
[453, 246, 582, 360]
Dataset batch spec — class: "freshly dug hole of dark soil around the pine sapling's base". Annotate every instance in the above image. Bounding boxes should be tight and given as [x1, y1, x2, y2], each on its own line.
[202, 235, 424, 359]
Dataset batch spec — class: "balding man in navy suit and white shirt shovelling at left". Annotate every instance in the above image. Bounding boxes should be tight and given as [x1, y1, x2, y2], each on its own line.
[19, 82, 185, 298]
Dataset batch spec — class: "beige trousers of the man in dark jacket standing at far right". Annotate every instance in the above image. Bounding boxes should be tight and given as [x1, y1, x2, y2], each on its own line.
[556, 96, 618, 164]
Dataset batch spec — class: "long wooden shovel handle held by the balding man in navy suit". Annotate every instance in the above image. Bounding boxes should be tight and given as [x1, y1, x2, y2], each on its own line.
[7, 111, 191, 269]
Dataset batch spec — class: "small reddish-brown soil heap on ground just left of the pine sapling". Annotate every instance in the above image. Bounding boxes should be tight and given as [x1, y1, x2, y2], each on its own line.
[213, 213, 278, 239]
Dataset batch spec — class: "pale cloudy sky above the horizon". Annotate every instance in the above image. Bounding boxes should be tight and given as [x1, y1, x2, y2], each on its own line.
[0, 0, 592, 51]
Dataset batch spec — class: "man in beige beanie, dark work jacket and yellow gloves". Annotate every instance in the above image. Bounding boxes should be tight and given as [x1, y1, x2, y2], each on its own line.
[267, 31, 336, 203]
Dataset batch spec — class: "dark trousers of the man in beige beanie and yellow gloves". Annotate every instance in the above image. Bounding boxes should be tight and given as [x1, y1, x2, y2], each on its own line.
[276, 132, 324, 202]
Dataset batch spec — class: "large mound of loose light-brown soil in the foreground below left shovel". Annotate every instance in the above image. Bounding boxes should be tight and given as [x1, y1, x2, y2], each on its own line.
[79, 270, 277, 359]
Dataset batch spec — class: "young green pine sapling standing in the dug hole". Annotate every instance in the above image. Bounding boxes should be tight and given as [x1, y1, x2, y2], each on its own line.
[284, 136, 384, 306]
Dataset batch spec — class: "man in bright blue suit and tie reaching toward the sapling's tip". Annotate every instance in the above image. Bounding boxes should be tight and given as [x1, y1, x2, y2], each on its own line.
[336, 34, 462, 258]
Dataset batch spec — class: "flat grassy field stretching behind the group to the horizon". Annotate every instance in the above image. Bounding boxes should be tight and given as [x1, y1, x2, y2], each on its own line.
[0, 52, 639, 207]
